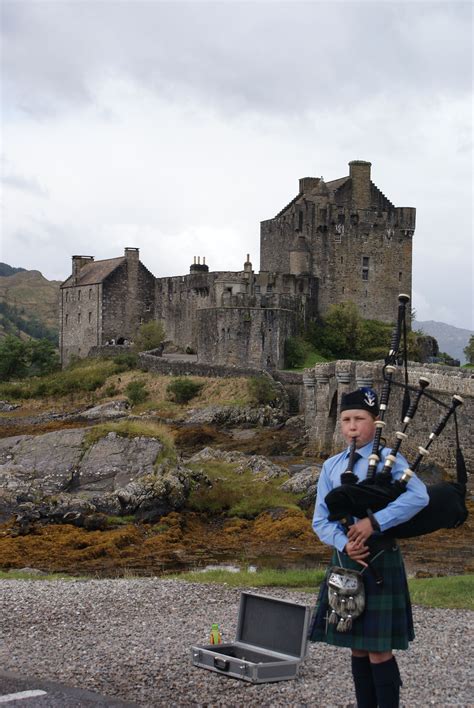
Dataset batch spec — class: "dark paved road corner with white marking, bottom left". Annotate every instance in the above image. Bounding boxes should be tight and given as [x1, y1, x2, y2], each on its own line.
[0, 672, 137, 708]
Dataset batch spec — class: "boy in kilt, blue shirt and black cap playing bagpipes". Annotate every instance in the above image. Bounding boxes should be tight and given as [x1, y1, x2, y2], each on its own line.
[310, 388, 429, 708]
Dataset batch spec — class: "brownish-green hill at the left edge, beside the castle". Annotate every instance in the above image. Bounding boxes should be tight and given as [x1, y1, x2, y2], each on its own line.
[0, 263, 61, 344]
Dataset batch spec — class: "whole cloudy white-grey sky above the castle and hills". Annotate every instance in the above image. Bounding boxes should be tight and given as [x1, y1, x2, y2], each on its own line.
[0, 0, 474, 328]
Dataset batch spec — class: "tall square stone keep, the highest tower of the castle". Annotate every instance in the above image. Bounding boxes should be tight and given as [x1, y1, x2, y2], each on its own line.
[260, 160, 416, 322]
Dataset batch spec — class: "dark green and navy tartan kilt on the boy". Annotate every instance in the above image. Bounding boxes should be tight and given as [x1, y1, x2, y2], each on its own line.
[308, 547, 415, 652]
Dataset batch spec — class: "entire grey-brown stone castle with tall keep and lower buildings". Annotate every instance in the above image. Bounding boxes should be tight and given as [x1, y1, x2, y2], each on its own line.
[60, 160, 416, 370]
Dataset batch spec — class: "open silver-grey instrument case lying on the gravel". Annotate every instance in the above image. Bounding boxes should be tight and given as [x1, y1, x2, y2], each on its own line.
[191, 592, 311, 683]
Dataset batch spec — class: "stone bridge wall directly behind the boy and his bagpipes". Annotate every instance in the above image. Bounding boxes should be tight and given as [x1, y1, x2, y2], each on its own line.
[303, 360, 474, 482]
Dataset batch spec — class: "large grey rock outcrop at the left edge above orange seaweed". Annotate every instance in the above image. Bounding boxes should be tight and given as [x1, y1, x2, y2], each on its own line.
[0, 429, 196, 525]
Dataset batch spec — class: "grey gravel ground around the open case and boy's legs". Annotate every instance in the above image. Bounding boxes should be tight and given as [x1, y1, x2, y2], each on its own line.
[0, 579, 474, 708]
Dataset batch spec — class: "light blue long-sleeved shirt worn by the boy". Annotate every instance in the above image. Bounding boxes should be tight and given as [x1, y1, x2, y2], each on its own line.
[313, 442, 429, 551]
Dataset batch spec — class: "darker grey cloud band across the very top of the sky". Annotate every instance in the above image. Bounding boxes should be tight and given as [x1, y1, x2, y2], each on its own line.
[2, 0, 472, 115]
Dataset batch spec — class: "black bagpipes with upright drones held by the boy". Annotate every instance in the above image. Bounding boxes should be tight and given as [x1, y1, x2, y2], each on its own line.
[325, 295, 468, 538]
